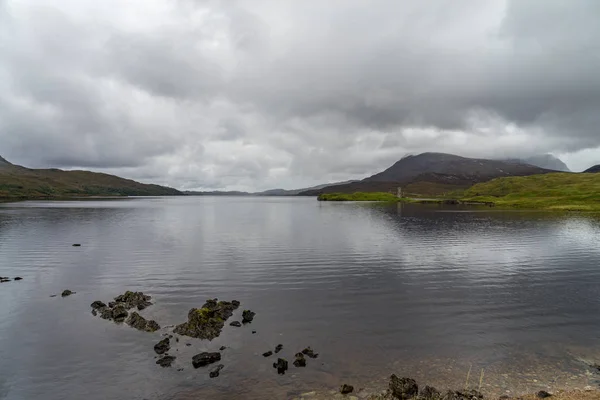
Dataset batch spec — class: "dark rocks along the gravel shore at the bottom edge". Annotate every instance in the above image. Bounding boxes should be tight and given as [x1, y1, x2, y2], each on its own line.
[360, 375, 483, 400]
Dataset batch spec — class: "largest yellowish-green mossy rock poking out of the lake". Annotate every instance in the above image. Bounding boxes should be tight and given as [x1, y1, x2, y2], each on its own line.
[173, 299, 239, 340]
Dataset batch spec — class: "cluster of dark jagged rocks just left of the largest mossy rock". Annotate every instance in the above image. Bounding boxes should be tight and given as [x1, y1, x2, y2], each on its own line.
[89, 291, 160, 332]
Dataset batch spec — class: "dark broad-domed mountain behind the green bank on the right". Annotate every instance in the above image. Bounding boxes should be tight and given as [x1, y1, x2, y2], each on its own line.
[300, 153, 552, 196]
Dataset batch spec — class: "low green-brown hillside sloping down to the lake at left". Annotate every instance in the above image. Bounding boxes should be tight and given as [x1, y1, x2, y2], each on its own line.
[0, 157, 183, 198]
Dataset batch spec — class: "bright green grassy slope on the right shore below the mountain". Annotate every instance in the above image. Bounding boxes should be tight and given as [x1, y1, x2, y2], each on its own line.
[464, 173, 600, 211]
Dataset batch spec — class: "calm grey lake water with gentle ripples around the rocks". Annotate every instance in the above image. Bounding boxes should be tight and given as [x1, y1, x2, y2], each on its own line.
[0, 197, 600, 400]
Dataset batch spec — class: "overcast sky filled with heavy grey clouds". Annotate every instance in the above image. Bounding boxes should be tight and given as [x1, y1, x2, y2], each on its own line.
[0, 0, 600, 191]
